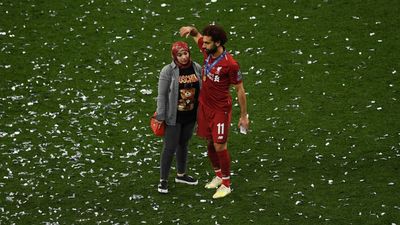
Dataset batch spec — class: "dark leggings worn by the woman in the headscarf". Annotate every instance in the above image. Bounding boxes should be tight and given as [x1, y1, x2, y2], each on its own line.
[160, 122, 195, 180]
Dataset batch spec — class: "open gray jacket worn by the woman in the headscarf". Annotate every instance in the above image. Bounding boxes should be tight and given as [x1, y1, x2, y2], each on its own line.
[156, 61, 201, 126]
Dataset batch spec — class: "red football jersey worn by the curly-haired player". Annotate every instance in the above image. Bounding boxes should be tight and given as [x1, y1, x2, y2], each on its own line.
[197, 38, 242, 112]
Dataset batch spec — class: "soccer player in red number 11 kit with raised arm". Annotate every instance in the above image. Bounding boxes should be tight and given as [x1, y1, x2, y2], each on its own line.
[179, 25, 249, 198]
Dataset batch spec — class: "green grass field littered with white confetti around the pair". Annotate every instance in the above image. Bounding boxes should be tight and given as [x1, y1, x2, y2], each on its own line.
[0, 0, 400, 225]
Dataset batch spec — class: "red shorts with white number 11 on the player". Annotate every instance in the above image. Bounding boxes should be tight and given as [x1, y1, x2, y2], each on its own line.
[197, 103, 232, 144]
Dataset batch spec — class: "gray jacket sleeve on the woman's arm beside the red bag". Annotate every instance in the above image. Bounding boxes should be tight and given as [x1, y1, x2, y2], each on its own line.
[156, 65, 171, 121]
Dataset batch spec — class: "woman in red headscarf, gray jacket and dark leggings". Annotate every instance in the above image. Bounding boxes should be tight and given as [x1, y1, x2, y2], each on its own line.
[156, 41, 201, 194]
